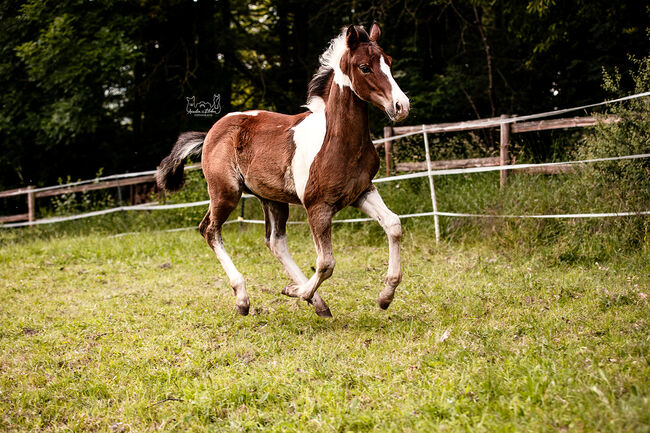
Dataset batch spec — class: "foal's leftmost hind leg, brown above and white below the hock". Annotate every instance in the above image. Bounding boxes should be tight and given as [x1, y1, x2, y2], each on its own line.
[199, 192, 250, 316]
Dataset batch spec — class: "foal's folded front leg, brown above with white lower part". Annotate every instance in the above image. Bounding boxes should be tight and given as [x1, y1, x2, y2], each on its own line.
[282, 204, 336, 301]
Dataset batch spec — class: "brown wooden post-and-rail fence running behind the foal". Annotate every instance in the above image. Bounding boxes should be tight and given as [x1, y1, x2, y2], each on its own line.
[0, 115, 617, 224]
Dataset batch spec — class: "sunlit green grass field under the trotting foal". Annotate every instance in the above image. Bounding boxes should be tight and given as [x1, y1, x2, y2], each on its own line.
[0, 219, 650, 432]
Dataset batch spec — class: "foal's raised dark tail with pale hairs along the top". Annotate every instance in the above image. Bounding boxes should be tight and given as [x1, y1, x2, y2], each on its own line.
[156, 132, 208, 191]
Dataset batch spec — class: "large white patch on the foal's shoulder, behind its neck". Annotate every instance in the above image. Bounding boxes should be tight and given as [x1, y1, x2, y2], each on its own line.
[291, 110, 326, 201]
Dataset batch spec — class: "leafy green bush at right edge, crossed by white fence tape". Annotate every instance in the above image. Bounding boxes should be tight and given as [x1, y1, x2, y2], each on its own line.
[560, 51, 650, 248]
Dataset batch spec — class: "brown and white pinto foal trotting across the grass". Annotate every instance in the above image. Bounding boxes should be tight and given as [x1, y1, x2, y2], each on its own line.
[156, 24, 409, 317]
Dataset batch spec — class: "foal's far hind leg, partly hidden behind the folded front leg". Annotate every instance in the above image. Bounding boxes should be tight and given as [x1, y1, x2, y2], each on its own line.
[261, 200, 332, 317]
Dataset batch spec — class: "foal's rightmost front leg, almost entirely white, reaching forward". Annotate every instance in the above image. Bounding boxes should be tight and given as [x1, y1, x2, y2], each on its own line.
[353, 185, 402, 310]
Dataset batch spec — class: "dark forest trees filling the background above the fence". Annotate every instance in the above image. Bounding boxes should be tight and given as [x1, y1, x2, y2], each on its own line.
[0, 0, 649, 189]
